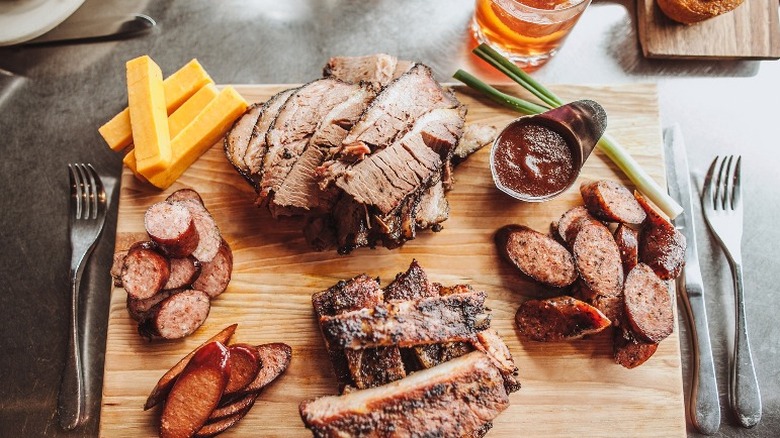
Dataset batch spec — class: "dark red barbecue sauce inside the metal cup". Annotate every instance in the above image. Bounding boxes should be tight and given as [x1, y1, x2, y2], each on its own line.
[495, 123, 576, 198]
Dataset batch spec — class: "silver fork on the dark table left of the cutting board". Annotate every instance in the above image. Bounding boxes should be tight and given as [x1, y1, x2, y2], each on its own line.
[57, 164, 107, 430]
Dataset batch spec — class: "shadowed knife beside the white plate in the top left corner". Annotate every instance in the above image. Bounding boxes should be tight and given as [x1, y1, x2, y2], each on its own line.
[23, 14, 157, 46]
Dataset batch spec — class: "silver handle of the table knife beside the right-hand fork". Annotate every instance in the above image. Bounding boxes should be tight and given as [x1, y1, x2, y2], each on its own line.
[678, 273, 720, 435]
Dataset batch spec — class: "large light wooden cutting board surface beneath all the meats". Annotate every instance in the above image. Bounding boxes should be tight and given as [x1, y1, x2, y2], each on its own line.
[100, 84, 685, 437]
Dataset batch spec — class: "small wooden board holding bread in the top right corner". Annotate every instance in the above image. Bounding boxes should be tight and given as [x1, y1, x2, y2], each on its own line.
[637, 0, 780, 59]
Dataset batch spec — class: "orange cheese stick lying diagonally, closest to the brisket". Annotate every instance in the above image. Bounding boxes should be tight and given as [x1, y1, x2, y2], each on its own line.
[144, 87, 249, 189]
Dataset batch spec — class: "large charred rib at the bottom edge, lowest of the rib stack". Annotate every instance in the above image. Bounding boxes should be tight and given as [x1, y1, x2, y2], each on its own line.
[299, 351, 509, 437]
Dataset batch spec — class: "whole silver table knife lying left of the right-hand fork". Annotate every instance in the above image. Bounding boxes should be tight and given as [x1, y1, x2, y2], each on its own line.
[664, 125, 720, 435]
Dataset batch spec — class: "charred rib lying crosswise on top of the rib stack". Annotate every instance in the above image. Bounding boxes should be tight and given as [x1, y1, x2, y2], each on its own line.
[320, 291, 490, 349]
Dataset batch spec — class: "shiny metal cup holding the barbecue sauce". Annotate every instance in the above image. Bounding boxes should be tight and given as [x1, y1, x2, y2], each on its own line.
[490, 100, 607, 202]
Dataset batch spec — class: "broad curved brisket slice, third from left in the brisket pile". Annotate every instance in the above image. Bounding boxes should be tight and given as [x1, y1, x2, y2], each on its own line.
[257, 78, 360, 204]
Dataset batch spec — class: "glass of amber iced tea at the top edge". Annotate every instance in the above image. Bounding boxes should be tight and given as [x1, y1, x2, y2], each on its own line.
[472, 0, 590, 69]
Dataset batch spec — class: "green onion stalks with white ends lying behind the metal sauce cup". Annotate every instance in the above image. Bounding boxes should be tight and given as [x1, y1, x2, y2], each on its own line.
[453, 44, 683, 219]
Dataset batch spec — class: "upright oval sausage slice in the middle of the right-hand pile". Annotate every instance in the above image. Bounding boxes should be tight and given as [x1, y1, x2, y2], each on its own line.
[572, 221, 623, 297]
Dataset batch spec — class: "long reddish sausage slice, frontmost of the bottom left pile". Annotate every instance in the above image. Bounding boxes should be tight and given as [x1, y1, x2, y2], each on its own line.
[160, 342, 230, 438]
